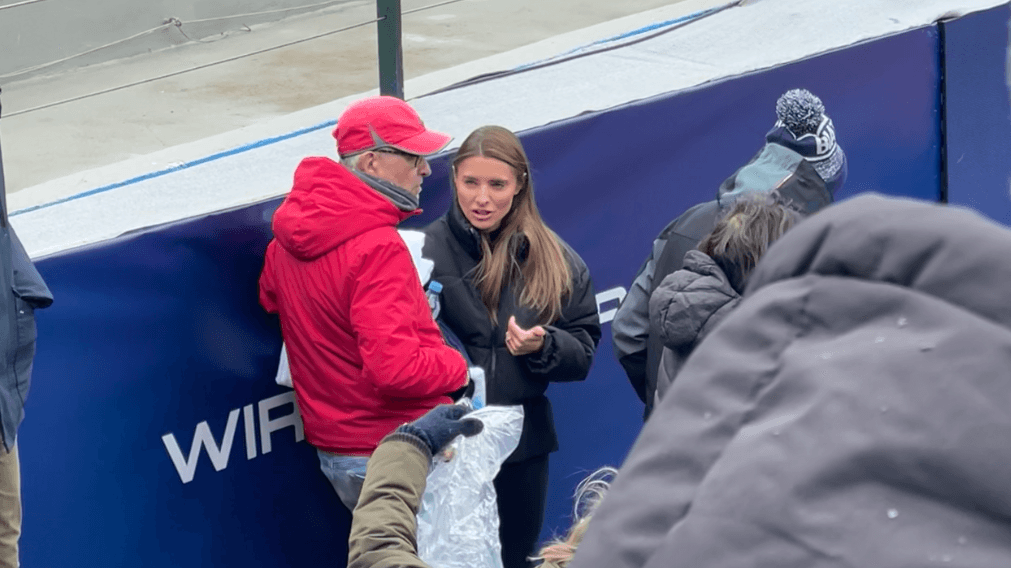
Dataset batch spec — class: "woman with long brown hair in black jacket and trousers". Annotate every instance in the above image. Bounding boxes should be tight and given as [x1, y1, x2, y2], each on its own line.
[423, 126, 601, 568]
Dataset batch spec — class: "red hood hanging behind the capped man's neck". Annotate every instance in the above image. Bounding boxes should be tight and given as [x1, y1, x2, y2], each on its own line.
[273, 158, 421, 261]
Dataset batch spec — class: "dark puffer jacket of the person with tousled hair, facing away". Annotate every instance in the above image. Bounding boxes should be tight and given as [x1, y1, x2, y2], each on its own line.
[649, 251, 741, 402]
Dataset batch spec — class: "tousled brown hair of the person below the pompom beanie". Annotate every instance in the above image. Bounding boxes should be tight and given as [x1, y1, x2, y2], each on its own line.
[699, 191, 803, 292]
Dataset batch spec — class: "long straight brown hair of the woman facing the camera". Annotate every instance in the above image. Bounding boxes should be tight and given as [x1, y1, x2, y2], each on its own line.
[452, 126, 572, 324]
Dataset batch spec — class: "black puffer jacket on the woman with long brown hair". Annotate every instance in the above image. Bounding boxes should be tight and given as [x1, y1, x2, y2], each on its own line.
[423, 204, 601, 463]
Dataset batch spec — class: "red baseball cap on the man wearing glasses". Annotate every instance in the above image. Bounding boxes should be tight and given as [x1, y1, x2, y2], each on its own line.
[334, 96, 453, 156]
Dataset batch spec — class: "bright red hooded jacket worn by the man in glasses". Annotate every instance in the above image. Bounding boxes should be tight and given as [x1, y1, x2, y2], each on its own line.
[260, 158, 467, 455]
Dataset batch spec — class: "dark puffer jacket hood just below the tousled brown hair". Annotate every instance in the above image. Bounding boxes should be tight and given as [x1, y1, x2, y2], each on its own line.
[650, 251, 740, 350]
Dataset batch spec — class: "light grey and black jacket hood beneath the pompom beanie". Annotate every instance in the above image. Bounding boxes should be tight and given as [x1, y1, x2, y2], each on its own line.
[716, 143, 832, 214]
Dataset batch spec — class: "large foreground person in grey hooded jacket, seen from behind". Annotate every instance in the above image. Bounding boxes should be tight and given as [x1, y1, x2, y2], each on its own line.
[570, 195, 1011, 568]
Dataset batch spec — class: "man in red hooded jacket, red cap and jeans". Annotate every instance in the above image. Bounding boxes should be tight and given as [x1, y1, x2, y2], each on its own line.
[260, 97, 467, 510]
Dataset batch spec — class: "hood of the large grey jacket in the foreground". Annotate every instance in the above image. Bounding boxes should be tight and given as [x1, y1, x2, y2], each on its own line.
[747, 194, 1011, 328]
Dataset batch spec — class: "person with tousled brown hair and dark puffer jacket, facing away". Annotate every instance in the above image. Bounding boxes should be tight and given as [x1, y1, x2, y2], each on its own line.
[649, 192, 801, 401]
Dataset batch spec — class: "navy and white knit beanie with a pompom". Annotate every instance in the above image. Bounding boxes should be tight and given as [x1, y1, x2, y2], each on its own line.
[765, 89, 848, 195]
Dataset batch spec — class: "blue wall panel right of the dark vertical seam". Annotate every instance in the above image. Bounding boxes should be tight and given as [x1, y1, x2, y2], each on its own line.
[943, 5, 1011, 224]
